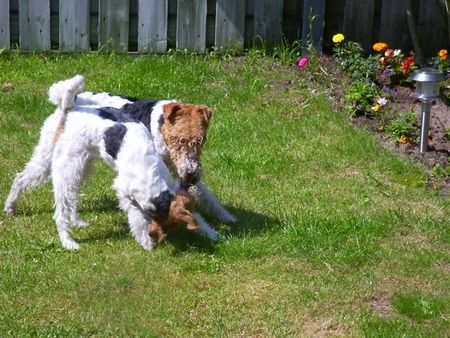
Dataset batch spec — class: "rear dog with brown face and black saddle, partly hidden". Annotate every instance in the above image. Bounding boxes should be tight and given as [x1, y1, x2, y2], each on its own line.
[76, 92, 236, 223]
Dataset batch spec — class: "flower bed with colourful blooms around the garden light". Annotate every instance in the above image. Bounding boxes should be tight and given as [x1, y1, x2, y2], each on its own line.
[299, 34, 450, 191]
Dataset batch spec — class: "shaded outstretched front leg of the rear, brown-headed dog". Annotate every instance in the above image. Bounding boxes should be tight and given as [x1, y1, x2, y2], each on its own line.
[189, 181, 237, 224]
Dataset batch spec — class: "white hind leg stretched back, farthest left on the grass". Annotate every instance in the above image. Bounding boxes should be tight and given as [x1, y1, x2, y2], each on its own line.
[4, 134, 52, 215]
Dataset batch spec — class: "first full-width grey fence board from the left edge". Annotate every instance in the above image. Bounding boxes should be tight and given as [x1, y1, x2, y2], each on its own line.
[19, 0, 50, 51]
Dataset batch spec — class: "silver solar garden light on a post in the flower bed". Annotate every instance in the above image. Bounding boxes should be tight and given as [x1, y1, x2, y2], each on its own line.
[411, 68, 445, 153]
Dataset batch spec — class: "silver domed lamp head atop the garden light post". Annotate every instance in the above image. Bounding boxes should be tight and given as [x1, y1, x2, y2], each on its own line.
[411, 68, 445, 101]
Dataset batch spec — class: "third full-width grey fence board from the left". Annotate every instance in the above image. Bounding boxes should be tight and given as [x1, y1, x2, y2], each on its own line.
[98, 0, 130, 52]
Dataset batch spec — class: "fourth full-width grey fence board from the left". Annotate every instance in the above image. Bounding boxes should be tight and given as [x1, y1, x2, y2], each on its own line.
[138, 0, 168, 53]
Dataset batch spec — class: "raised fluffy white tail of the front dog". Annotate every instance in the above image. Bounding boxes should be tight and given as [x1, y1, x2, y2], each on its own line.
[48, 75, 84, 146]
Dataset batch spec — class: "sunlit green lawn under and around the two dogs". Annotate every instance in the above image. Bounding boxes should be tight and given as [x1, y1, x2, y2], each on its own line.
[0, 52, 450, 337]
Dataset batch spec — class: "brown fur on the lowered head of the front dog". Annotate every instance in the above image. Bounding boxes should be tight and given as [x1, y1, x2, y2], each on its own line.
[148, 189, 198, 243]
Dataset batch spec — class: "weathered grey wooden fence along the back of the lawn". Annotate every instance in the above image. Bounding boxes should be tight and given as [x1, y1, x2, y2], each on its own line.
[0, 0, 449, 55]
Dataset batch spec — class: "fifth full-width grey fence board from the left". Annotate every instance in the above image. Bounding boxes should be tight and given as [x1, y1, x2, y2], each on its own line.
[176, 0, 206, 53]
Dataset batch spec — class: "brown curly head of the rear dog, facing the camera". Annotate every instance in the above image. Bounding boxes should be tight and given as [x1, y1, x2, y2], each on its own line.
[161, 103, 212, 184]
